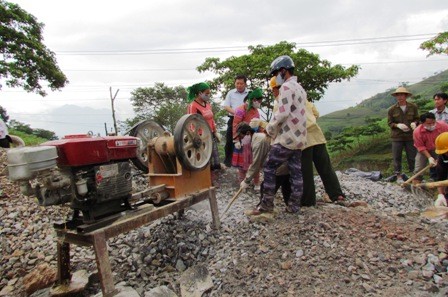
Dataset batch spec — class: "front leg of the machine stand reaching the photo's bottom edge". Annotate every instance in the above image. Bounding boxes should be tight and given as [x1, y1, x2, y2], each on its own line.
[93, 231, 118, 297]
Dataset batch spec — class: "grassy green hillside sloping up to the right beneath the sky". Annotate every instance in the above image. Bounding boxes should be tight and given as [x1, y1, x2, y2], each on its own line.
[318, 70, 448, 134]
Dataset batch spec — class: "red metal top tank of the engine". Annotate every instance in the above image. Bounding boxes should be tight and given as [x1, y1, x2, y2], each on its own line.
[42, 134, 138, 166]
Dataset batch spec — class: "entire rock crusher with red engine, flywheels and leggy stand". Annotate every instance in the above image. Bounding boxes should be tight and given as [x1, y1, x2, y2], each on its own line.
[7, 115, 220, 296]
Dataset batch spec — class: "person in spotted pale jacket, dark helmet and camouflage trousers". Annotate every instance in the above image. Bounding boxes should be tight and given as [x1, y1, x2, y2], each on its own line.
[247, 56, 306, 216]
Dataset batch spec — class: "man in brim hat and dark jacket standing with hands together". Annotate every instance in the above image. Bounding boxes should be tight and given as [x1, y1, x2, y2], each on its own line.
[387, 87, 419, 183]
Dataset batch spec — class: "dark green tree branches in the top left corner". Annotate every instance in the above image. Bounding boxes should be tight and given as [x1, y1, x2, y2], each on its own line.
[0, 0, 68, 96]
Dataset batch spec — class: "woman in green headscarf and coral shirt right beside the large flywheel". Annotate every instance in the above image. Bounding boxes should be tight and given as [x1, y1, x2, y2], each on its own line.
[187, 82, 225, 170]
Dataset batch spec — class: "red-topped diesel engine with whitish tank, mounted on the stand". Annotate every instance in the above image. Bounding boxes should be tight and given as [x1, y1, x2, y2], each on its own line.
[8, 135, 140, 222]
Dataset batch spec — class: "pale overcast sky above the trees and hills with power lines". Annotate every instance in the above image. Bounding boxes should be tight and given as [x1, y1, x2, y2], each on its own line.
[0, 0, 448, 137]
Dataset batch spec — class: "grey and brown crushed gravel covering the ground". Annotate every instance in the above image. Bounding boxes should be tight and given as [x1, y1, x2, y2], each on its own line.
[0, 149, 448, 296]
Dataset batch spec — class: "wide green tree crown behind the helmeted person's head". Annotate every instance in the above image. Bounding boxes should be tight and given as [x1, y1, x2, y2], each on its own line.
[197, 41, 359, 106]
